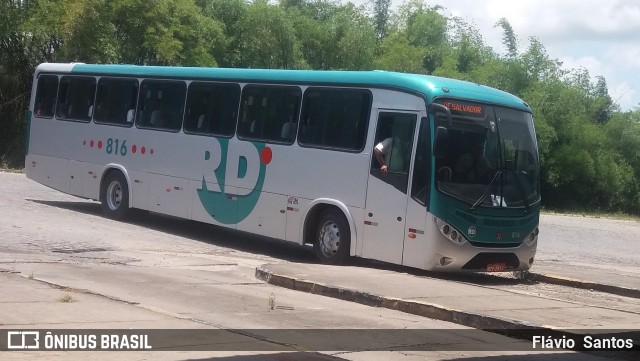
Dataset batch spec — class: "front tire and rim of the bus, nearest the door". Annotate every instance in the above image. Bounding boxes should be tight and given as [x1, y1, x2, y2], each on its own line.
[313, 209, 351, 265]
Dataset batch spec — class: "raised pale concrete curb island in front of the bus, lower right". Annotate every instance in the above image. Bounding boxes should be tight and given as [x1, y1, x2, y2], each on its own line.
[256, 263, 640, 358]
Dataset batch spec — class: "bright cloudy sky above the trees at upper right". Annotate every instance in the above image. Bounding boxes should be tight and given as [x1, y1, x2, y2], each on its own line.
[351, 0, 640, 111]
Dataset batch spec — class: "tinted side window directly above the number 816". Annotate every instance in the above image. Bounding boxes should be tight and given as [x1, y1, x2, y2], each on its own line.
[94, 78, 138, 126]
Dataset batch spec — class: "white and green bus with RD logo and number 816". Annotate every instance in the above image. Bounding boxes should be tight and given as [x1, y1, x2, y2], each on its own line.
[25, 64, 540, 271]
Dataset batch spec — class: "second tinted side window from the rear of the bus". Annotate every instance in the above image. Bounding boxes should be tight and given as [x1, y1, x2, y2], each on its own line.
[56, 76, 96, 121]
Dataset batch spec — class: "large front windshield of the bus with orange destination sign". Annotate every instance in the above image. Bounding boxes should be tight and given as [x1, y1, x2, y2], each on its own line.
[436, 100, 540, 210]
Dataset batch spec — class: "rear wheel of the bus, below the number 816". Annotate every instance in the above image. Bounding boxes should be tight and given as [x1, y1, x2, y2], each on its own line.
[100, 170, 129, 220]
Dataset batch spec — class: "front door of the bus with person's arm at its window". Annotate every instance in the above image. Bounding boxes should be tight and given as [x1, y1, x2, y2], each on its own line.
[362, 110, 418, 264]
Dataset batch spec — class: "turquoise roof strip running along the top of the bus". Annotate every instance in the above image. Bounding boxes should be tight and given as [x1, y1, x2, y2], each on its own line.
[36, 63, 531, 111]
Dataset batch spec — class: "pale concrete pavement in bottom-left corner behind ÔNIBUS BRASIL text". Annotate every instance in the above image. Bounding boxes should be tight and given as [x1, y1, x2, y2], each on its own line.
[0, 270, 340, 361]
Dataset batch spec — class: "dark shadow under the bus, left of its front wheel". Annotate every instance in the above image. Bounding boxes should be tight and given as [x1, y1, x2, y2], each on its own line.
[27, 199, 315, 263]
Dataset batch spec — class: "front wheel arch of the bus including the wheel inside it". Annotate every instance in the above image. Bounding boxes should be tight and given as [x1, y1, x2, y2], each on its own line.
[304, 203, 355, 264]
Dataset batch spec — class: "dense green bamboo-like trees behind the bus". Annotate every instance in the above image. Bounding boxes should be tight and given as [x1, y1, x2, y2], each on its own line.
[0, 0, 640, 214]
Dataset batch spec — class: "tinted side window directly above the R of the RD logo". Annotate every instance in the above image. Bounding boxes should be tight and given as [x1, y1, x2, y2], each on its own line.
[184, 82, 240, 137]
